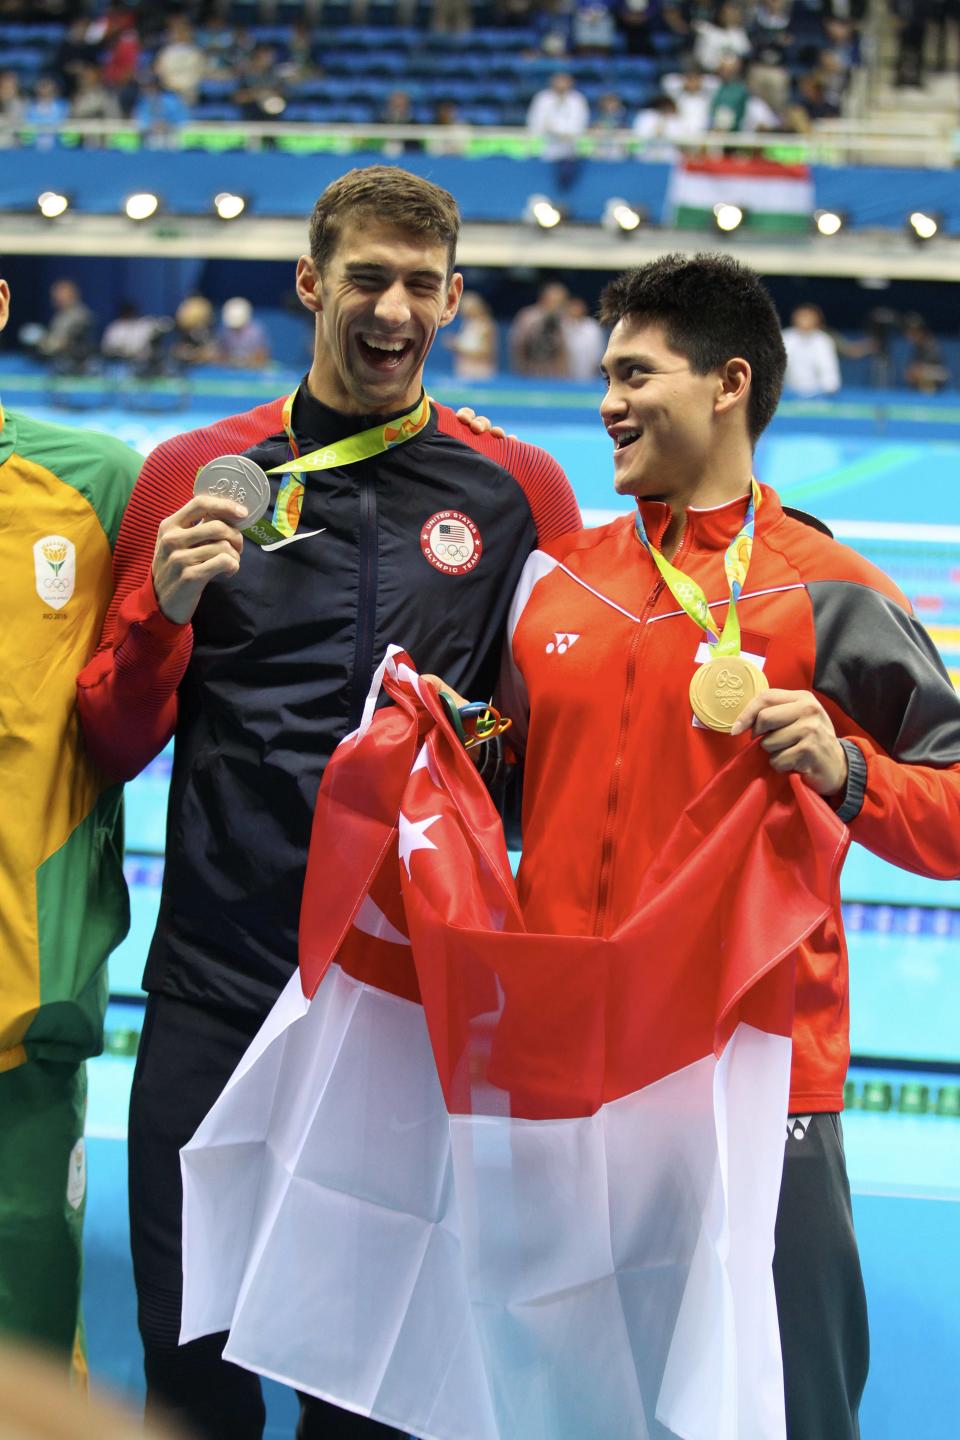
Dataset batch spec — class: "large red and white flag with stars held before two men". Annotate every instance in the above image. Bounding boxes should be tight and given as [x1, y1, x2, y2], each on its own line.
[181, 651, 846, 1440]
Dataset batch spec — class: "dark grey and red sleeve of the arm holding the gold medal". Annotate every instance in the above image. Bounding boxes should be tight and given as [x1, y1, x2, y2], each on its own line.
[807, 582, 960, 880]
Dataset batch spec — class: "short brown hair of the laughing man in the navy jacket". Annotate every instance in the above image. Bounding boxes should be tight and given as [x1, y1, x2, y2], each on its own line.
[309, 166, 461, 275]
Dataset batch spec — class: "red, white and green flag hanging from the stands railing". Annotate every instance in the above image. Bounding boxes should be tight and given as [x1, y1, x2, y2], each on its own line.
[666, 156, 815, 235]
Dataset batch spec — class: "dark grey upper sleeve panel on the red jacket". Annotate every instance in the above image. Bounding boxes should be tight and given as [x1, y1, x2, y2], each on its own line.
[807, 580, 960, 769]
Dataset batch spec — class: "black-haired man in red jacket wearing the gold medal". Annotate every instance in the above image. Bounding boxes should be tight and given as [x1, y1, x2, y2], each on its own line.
[489, 255, 960, 1440]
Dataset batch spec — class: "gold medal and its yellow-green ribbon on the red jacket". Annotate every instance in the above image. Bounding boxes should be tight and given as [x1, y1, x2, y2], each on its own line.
[636, 478, 767, 732]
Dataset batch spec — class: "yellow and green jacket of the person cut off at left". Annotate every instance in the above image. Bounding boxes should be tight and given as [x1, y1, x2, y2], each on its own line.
[0, 408, 141, 1071]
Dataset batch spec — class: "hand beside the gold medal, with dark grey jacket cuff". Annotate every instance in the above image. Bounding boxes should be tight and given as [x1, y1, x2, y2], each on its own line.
[730, 690, 846, 795]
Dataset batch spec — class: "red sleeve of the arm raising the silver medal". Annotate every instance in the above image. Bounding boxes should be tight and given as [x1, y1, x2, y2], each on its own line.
[76, 400, 282, 780]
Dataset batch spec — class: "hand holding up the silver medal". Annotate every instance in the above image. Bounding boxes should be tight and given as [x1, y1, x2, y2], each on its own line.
[153, 495, 248, 625]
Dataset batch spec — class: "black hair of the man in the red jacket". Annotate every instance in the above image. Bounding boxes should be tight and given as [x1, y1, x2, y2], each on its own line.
[600, 255, 787, 445]
